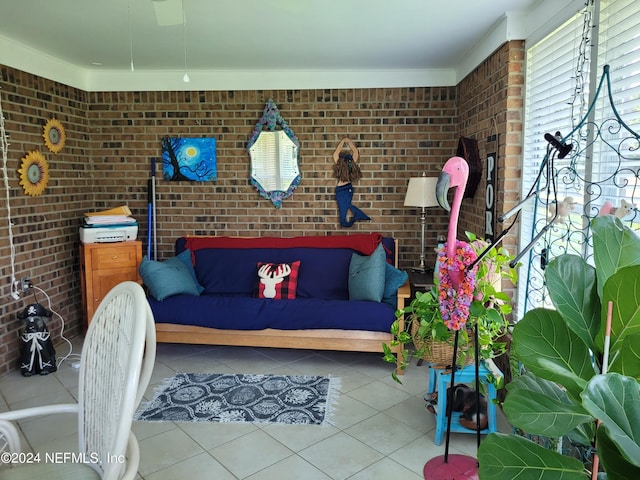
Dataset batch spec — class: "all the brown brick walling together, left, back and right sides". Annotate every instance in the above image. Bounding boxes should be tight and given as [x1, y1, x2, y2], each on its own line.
[0, 42, 522, 373]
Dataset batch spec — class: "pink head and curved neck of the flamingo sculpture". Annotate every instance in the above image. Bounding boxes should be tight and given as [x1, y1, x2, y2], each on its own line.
[436, 157, 469, 288]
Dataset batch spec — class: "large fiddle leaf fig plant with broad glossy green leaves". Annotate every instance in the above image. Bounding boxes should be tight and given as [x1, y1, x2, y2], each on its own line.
[478, 215, 640, 480]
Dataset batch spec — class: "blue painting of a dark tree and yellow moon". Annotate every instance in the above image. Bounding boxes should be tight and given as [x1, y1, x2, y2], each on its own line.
[161, 137, 218, 182]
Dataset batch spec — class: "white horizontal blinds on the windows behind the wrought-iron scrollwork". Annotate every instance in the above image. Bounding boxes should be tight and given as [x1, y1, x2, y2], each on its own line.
[517, 0, 640, 318]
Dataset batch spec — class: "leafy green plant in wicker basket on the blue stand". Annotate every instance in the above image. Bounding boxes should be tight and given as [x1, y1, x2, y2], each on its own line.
[383, 232, 517, 382]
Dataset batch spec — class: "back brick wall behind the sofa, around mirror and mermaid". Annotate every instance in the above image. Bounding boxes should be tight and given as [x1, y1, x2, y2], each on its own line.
[88, 88, 457, 265]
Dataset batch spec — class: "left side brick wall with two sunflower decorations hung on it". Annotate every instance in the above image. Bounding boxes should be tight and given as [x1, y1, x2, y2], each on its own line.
[0, 66, 94, 373]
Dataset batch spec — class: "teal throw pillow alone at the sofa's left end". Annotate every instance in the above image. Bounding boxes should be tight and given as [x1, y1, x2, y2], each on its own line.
[138, 255, 199, 300]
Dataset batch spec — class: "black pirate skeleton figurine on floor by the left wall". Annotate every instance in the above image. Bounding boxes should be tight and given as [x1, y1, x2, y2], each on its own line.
[18, 303, 57, 377]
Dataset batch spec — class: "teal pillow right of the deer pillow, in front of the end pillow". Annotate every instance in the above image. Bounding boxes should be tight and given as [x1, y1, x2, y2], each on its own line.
[349, 244, 387, 302]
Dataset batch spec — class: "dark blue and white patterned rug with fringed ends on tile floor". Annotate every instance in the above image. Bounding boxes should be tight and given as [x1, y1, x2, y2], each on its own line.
[134, 373, 339, 425]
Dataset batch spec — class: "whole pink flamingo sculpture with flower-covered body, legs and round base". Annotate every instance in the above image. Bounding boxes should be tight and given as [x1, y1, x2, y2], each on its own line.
[423, 157, 480, 480]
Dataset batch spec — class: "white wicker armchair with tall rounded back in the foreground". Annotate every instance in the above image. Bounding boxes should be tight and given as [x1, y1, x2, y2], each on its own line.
[0, 282, 156, 480]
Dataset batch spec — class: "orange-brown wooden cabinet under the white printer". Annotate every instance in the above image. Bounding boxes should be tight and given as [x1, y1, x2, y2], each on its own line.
[80, 240, 142, 328]
